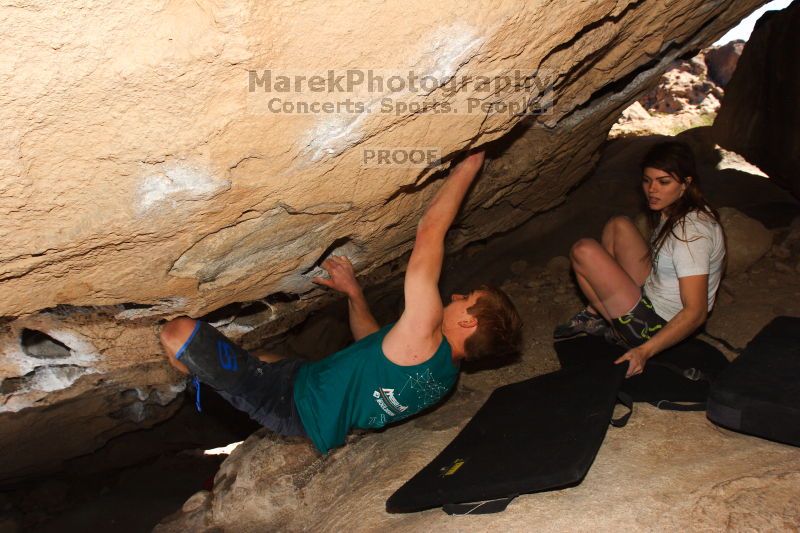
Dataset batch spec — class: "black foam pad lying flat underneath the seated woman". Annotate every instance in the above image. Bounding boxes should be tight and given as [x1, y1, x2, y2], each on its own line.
[554, 335, 729, 409]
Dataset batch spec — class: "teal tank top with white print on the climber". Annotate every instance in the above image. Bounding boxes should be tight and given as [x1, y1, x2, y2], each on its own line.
[294, 324, 458, 453]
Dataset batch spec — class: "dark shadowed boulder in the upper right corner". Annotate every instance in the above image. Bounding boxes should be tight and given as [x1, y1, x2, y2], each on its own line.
[714, 1, 800, 198]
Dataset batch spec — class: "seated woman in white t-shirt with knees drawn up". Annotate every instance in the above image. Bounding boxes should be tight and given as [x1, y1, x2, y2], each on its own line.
[554, 141, 725, 377]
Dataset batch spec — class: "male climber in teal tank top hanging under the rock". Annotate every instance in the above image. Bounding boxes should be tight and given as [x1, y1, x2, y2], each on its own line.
[161, 151, 521, 453]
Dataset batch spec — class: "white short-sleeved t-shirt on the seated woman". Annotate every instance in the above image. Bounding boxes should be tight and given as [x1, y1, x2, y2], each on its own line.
[644, 211, 725, 320]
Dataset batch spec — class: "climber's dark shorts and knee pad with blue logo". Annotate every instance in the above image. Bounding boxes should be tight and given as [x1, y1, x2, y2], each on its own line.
[175, 320, 306, 436]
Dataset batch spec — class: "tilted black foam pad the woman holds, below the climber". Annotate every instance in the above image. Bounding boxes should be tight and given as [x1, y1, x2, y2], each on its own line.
[386, 362, 627, 514]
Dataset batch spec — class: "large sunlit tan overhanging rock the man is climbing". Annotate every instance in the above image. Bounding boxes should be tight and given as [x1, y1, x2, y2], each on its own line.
[0, 0, 763, 480]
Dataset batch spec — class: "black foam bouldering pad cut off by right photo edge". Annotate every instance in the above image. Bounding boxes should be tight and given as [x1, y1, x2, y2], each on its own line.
[706, 316, 800, 446]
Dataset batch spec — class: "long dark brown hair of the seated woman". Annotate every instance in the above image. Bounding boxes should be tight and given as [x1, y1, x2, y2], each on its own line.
[640, 141, 719, 265]
